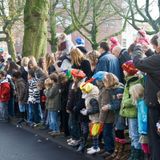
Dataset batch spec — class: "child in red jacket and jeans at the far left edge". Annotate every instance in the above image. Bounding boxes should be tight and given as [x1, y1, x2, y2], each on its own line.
[0, 71, 10, 121]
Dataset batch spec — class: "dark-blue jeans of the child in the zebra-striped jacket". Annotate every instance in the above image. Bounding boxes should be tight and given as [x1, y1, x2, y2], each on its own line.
[28, 103, 42, 123]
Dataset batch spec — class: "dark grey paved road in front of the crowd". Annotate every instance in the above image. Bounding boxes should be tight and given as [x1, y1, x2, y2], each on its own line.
[0, 123, 90, 160]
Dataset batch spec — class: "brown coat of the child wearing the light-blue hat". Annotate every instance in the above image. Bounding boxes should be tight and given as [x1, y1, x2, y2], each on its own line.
[99, 88, 115, 123]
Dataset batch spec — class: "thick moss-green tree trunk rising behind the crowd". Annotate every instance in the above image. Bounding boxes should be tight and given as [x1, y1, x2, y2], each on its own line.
[23, 0, 49, 58]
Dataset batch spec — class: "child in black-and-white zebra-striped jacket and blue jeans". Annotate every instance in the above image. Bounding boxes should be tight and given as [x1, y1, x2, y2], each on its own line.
[28, 69, 41, 126]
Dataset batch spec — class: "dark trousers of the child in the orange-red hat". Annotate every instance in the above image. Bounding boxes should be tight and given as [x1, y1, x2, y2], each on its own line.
[69, 113, 80, 140]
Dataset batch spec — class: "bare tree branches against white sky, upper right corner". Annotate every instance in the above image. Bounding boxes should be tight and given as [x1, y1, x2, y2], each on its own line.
[109, 0, 160, 35]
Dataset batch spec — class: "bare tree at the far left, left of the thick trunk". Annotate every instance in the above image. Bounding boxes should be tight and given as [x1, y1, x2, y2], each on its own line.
[0, 0, 24, 59]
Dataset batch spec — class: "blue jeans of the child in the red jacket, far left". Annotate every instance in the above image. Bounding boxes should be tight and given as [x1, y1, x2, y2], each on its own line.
[0, 102, 8, 120]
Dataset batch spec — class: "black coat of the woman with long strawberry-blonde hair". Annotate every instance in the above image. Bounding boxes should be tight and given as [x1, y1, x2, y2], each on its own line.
[72, 60, 92, 78]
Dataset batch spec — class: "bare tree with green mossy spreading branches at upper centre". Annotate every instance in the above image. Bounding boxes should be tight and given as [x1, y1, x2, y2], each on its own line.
[58, 0, 126, 49]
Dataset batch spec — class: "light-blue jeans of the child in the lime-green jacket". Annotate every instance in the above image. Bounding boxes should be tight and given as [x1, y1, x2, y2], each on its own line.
[128, 118, 141, 149]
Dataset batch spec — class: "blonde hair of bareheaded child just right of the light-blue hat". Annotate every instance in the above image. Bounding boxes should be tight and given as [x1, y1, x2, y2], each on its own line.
[103, 73, 120, 89]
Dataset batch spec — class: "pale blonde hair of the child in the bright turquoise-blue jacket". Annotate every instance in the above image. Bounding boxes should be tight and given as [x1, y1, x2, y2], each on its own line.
[129, 83, 144, 103]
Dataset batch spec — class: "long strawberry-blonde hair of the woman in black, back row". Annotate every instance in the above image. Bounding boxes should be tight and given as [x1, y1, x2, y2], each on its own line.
[70, 48, 85, 66]
